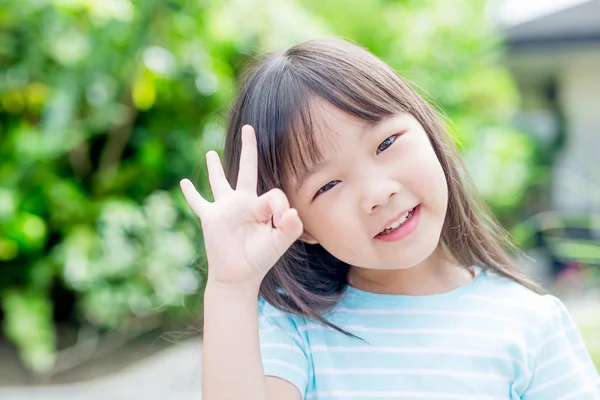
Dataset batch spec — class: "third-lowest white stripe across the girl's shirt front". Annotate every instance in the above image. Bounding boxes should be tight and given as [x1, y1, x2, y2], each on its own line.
[310, 345, 525, 368]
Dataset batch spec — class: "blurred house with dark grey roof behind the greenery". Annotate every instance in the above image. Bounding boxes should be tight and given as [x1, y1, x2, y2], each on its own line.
[505, 0, 600, 213]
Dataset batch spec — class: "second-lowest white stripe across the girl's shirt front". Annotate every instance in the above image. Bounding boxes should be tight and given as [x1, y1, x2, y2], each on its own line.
[315, 368, 511, 380]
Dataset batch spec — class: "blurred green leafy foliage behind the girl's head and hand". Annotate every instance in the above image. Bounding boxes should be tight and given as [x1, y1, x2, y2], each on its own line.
[0, 0, 533, 372]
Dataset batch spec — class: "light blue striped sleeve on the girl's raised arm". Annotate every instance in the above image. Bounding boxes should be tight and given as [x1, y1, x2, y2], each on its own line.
[258, 298, 308, 398]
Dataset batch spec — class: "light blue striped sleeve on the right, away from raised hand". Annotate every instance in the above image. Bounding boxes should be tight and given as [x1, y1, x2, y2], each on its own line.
[522, 295, 600, 400]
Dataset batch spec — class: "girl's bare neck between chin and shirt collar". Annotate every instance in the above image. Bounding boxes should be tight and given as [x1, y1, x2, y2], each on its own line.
[348, 246, 473, 296]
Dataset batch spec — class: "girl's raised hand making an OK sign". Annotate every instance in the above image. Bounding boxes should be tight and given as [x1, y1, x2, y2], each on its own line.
[181, 125, 303, 289]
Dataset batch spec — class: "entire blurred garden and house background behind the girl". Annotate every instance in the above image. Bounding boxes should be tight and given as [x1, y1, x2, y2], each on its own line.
[0, 0, 600, 399]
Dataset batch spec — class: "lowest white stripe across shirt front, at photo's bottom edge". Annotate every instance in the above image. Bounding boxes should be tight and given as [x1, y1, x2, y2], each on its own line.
[306, 390, 506, 400]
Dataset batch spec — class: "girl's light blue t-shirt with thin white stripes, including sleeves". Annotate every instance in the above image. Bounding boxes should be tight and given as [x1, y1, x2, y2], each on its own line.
[259, 271, 600, 400]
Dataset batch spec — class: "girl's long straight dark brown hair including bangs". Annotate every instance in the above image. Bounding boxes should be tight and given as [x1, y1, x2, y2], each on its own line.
[224, 38, 541, 330]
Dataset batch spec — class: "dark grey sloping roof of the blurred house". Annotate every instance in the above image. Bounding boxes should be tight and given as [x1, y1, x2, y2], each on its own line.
[505, 0, 600, 49]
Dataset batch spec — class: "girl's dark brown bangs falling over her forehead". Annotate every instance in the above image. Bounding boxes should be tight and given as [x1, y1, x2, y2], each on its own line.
[251, 43, 412, 192]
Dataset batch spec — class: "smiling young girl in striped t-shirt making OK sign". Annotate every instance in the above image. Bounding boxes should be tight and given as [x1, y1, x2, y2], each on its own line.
[181, 39, 600, 400]
